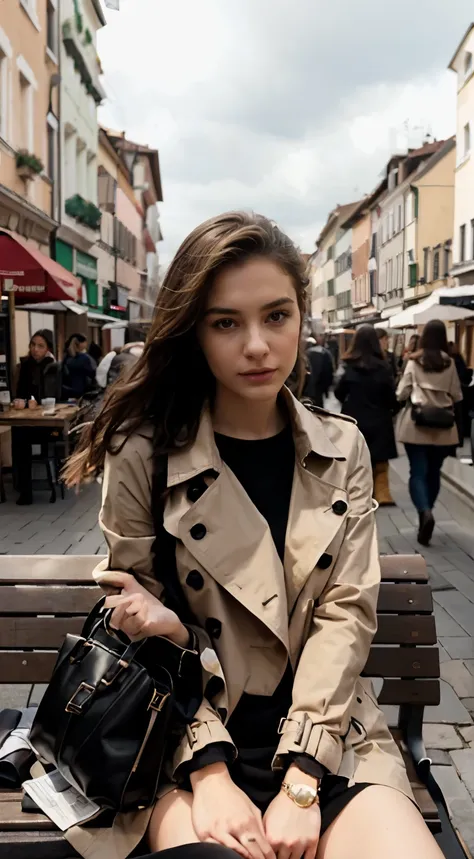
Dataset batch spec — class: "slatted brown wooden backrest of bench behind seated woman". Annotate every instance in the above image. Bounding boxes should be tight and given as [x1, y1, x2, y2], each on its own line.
[0, 555, 440, 705]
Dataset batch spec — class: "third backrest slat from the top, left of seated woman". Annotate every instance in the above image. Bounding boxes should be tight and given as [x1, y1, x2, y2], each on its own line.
[0, 616, 86, 648]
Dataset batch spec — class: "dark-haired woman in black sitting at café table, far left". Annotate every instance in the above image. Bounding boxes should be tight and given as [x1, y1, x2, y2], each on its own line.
[12, 328, 59, 504]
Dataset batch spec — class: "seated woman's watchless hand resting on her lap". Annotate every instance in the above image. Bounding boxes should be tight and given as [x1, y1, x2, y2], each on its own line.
[191, 763, 276, 859]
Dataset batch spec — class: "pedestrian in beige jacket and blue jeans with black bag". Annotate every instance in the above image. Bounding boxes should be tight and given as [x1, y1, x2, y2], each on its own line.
[397, 319, 462, 546]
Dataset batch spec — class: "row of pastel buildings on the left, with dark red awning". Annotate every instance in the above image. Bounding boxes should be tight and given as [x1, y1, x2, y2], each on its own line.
[0, 0, 163, 387]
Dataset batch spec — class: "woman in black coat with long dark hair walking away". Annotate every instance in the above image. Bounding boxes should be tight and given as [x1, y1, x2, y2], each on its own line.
[334, 325, 399, 506]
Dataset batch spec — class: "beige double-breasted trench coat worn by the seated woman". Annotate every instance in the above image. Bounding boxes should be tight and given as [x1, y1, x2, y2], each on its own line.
[66, 391, 412, 859]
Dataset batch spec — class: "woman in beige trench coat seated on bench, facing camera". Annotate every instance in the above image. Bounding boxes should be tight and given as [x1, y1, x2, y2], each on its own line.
[67, 212, 441, 859]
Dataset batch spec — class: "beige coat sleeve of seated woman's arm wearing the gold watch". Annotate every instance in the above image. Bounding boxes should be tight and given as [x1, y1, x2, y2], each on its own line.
[273, 433, 380, 774]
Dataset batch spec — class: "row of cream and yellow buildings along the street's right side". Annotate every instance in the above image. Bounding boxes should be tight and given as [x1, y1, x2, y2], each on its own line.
[309, 25, 474, 361]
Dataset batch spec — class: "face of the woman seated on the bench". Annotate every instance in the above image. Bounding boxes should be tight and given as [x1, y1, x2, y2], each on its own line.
[198, 258, 301, 401]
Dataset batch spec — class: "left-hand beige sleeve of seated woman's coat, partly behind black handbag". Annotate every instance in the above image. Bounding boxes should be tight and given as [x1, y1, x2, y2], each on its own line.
[93, 436, 236, 780]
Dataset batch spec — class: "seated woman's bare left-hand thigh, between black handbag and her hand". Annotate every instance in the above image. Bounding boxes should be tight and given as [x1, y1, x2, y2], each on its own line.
[147, 790, 199, 851]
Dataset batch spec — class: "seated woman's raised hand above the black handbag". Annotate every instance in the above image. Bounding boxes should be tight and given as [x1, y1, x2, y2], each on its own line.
[102, 572, 189, 647]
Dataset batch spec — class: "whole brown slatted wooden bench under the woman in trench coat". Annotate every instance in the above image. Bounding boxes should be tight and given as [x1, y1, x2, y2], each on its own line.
[0, 555, 468, 859]
